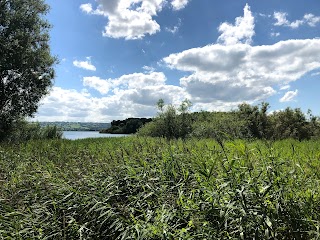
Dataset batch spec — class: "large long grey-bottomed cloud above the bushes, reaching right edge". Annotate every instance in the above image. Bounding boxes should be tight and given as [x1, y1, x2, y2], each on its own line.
[163, 39, 320, 103]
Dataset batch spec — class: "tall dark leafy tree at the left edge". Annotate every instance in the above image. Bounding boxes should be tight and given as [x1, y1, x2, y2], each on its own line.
[0, 0, 57, 140]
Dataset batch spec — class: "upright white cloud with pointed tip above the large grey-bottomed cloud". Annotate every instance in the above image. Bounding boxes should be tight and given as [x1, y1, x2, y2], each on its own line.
[218, 4, 255, 45]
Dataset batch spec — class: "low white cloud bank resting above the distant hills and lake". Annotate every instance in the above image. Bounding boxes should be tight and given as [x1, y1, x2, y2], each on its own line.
[35, 72, 189, 122]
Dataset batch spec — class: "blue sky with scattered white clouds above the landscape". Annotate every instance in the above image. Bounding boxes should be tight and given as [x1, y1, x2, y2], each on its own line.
[35, 0, 320, 122]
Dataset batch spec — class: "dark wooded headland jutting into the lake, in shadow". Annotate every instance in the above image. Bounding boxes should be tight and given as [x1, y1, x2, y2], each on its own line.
[100, 118, 152, 134]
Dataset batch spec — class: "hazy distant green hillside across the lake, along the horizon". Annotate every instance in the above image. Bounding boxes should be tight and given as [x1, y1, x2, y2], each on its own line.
[39, 122, 111, 131]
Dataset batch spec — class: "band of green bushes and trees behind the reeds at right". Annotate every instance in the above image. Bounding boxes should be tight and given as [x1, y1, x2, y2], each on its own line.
[138, 101, 320, 140]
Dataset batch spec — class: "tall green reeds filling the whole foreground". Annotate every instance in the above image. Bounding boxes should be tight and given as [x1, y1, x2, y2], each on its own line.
[0, 137, 320, 240]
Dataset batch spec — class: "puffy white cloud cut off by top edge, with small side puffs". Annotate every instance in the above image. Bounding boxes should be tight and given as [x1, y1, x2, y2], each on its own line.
[80, 0, 188, 40]
